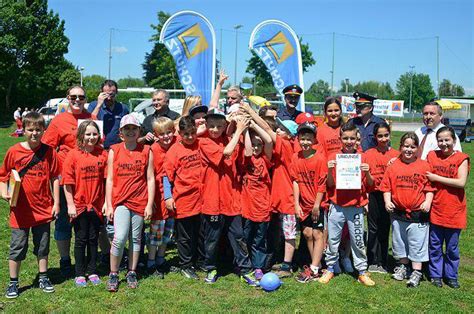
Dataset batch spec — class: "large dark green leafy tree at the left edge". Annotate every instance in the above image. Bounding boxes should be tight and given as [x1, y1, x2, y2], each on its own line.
[0, 0, 74, 111]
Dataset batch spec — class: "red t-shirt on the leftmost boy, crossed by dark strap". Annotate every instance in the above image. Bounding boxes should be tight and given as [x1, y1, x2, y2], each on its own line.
[0, 143, 60, 228]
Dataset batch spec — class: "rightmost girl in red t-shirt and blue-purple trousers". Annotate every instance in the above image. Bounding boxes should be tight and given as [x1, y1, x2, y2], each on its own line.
[426, 126, 470, 289]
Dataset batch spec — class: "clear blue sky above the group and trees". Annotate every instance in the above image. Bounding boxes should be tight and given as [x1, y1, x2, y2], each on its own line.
[49, 0, 474, 94]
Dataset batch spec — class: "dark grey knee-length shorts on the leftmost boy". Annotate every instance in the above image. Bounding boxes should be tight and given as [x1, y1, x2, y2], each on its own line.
[8, 222, 51, 262]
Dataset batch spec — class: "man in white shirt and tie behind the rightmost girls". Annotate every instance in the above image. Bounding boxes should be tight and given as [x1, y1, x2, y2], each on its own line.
[415, 102, 462, 160]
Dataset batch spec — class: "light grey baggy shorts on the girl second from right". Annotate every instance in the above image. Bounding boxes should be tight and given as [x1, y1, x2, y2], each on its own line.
[392, 219, 430, 263]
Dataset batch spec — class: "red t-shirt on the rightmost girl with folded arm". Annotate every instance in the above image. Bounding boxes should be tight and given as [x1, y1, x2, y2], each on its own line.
[426, 150, 470, 229]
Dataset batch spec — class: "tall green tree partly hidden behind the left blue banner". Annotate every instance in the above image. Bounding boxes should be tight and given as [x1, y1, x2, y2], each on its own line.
[142, 11, 182, 89]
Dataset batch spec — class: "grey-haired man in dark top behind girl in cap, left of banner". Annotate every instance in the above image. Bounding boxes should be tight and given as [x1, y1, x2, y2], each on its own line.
[138, 89, 179, 144]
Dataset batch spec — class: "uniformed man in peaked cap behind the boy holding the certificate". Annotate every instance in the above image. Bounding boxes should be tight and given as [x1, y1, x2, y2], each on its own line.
[350, 92, 386, 152]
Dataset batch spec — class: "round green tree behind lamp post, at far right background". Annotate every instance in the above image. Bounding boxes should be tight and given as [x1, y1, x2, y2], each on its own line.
[396, 72, 436, 110]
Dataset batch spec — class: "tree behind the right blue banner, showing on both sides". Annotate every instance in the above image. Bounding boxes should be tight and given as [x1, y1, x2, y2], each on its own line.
[245, 37, 316, 91]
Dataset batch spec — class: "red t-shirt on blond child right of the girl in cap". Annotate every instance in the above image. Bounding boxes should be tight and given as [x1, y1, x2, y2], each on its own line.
[151, 141, 174, 220]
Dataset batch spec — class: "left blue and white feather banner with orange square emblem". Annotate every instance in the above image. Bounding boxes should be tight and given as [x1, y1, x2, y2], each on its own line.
[160, 11, 216, 105]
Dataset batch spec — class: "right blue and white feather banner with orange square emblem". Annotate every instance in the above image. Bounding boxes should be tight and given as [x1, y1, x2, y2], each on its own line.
[249, 20, 304, 111]
